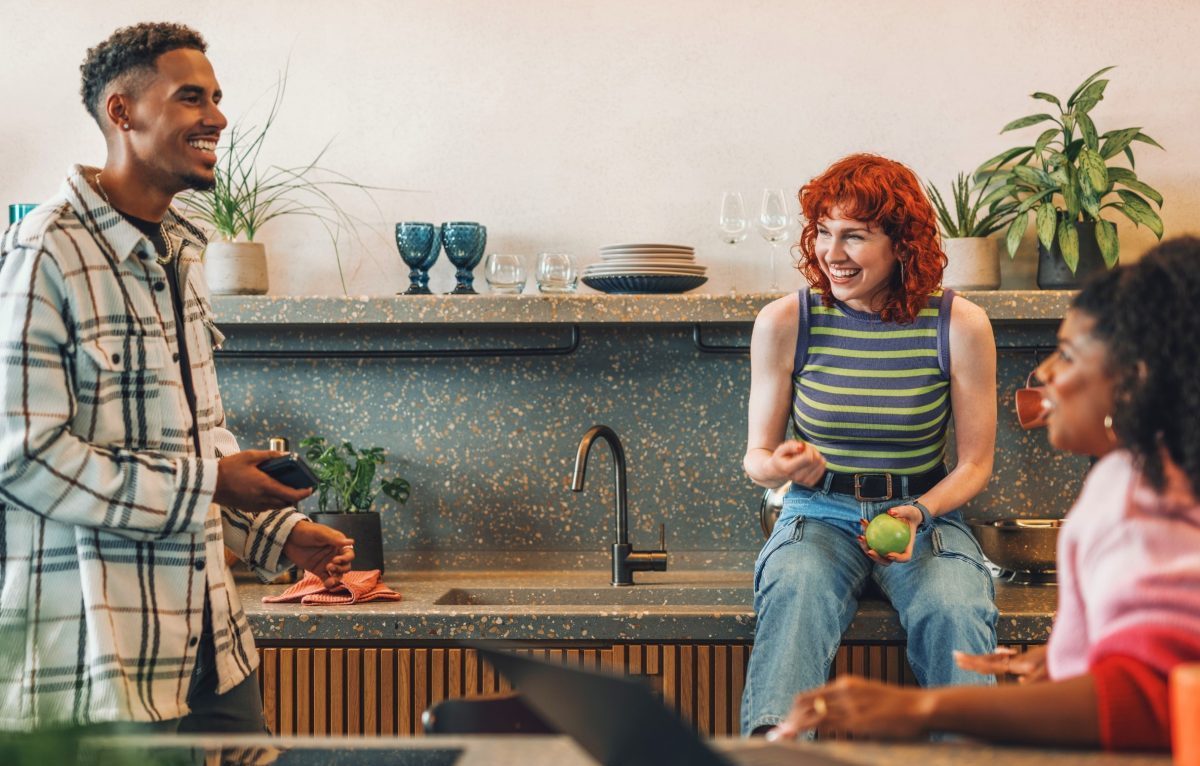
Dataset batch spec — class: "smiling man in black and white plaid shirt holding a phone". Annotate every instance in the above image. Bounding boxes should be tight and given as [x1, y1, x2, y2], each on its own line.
[0, 24, 354, 732]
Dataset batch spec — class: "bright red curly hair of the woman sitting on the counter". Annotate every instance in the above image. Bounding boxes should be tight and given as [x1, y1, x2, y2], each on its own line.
[797, 154, 946, 324]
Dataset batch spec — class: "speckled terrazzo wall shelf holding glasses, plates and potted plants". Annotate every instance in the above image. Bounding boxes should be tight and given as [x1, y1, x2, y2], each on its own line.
[212, 291, 1074, 325]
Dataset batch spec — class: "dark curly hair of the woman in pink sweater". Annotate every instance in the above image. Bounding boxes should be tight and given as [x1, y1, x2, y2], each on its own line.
[1072, 237, 1200, 491]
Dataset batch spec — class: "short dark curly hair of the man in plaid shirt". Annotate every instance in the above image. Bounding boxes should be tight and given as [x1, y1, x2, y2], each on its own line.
[79, 22, 209, 126]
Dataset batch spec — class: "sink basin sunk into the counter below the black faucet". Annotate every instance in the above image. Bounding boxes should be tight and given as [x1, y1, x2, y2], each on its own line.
[433, 585, 752, 606]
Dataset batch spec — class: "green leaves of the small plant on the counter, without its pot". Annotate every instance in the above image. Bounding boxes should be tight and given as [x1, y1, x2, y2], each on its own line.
[300, 436, 410, 514]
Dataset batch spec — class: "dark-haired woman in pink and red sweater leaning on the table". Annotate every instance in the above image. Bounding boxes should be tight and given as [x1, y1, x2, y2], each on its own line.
[772, 238, 1200, 750]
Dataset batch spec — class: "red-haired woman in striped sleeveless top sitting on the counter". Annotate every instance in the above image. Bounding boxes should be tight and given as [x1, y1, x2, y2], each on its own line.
[742, 154, 996, 735]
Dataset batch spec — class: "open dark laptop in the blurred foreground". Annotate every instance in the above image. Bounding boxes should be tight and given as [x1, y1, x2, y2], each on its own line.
[467, 644, 846, 766]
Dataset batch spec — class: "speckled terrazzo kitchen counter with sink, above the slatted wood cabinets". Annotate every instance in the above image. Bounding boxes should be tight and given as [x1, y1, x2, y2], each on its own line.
[239, 561, 1057, 642]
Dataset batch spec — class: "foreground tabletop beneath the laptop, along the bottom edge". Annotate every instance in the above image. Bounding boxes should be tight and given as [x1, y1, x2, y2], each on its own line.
[92, 735, 1171, 766]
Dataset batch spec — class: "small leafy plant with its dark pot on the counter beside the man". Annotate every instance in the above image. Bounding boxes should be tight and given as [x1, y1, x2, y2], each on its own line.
[300, 436, 410, 571]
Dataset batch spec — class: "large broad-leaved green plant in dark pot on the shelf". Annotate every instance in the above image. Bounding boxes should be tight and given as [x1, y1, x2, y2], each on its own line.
[977, 66, 1163, 288]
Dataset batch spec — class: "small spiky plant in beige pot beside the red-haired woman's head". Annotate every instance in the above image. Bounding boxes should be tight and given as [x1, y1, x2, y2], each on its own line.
[925, 173, 1016, 289]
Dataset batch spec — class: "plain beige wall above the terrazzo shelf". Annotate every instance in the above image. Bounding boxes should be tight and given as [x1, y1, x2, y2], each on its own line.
[0, 0, 1200, 294]
